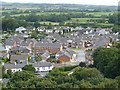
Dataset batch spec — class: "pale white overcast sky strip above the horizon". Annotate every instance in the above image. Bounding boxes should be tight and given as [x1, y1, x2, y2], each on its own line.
[0, 0, 120, 6]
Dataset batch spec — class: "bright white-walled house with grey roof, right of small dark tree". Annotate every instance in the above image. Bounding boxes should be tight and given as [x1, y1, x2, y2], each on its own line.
[32, 62, 53, 72]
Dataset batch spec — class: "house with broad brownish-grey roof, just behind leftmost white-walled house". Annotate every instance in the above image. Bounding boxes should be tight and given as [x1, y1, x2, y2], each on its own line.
[10, 53, 28, 63]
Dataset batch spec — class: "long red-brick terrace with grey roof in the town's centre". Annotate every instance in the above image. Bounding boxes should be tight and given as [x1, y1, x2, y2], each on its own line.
[33, 42, 62, 53]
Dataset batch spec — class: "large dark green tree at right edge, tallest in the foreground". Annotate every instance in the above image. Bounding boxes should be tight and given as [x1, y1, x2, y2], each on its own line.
[93, 48, 120, 78]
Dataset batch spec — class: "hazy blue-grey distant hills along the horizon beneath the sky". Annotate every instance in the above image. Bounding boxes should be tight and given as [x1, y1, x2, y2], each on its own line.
[0, 1, 118, 10]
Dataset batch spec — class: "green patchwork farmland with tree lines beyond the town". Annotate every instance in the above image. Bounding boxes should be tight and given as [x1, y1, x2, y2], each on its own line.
[0, 4, 117, 27]
